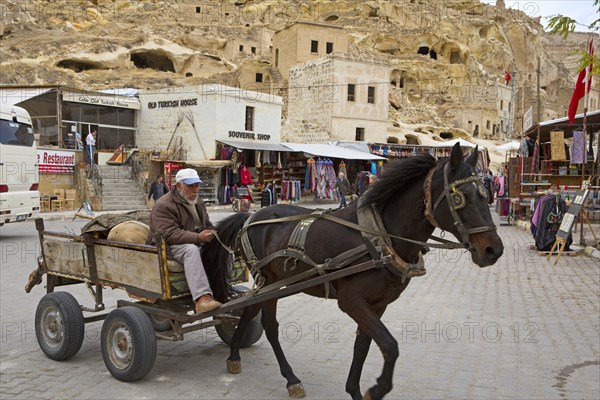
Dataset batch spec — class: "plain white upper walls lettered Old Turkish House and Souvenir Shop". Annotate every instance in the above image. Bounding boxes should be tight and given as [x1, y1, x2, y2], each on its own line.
[136, 84, 282, 160]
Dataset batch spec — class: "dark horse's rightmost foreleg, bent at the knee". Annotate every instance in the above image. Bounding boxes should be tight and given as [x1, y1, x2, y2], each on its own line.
[340, 302, 398, 400]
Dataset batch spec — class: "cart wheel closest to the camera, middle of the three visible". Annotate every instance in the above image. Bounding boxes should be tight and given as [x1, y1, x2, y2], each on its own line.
[100, 307, 156, 382]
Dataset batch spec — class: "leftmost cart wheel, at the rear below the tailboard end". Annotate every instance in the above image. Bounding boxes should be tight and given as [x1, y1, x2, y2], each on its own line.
[35, 292, 85, 361]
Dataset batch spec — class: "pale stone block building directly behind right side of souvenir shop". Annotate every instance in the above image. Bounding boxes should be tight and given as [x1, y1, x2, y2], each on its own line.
[282, 53, 390, 143]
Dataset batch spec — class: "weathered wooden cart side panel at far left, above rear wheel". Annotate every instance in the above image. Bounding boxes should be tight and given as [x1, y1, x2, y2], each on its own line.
[43, 238, 90, 279]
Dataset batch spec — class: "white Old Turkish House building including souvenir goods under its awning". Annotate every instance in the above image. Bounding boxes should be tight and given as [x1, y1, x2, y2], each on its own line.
[136, 84, 287, 203]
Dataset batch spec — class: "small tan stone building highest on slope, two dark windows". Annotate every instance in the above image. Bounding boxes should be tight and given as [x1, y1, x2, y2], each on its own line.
[272, 22, 348, 79]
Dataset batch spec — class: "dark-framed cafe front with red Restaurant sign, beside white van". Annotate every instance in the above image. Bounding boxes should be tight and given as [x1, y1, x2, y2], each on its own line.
[0, 86, 140, 203]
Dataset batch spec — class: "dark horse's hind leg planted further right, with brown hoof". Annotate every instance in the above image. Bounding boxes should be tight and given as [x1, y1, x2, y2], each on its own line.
[262, 299, 306, 399]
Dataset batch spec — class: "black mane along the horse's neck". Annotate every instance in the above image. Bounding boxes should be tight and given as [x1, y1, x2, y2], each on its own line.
[362, 154, 437, 208]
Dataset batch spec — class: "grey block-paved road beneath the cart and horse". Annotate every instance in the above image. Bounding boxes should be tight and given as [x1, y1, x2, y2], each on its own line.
[0, 213, 600, 399]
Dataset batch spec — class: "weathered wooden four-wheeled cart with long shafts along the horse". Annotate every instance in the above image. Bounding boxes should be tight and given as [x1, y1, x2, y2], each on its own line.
[25, 218, 389, 382]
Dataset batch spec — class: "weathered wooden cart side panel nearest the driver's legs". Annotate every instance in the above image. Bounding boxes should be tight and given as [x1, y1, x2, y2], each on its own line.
[94, 246, 163, 293]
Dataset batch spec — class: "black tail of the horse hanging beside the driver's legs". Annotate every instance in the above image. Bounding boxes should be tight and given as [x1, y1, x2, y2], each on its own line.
[202, 213, 250, 302]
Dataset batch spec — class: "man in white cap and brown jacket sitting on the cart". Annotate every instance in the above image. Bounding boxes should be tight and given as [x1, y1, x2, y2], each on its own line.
[148, 168, 222, 313]
